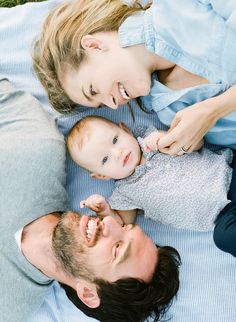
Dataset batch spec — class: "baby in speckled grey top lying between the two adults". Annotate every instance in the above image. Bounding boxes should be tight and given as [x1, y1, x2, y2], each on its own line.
[67, 116, 232, 231]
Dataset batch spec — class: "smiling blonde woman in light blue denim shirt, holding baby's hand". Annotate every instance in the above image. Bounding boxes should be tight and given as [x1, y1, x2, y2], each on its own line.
[34, 0, 236, 155]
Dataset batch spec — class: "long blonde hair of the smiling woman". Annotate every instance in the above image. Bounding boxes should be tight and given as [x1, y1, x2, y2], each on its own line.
[33, 0, 148, 113]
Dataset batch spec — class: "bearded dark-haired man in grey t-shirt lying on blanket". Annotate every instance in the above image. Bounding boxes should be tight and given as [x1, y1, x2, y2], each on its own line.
[0, 75, 180, 322]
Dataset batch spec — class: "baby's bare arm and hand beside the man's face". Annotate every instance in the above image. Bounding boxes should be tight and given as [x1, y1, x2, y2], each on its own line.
[80, 194, 136, 225]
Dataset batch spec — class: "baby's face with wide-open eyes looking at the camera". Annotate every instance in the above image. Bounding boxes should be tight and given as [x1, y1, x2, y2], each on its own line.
[75, 121, 141, 179]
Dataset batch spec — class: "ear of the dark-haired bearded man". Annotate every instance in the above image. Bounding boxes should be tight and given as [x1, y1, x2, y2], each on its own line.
[76, 280, 101, 309]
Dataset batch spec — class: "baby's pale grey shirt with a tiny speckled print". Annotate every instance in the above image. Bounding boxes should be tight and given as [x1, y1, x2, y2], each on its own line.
[108, 129, 232, 231]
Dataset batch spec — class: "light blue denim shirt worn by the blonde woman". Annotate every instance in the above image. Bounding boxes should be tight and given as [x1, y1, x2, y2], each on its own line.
[119, 0, 236, 148]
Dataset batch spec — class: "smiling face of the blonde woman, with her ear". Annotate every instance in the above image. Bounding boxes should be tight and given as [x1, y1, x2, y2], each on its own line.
[61, 33, 151, 109]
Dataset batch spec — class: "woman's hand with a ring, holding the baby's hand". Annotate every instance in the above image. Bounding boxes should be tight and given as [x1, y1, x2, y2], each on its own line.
[158, 99, 217, 155]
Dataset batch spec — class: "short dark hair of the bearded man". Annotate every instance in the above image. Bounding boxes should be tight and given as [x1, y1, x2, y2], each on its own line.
[62, 246, 181, 322]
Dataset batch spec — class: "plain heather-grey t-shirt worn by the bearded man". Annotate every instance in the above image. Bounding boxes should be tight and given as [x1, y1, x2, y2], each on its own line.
[0, 75, 67, 322]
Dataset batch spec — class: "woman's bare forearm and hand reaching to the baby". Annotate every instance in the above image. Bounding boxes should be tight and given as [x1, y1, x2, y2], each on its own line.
[158, 85, 236, 155]
